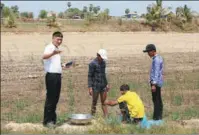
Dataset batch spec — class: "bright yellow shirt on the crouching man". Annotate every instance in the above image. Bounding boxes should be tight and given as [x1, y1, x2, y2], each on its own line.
[117, 91, 144, 118]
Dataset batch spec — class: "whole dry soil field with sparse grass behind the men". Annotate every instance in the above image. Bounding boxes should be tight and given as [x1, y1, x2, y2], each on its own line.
[1, 32, 199, 133]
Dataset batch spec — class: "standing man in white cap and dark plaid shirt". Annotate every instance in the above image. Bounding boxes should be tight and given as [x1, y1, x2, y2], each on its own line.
[88, 49, 109, 117]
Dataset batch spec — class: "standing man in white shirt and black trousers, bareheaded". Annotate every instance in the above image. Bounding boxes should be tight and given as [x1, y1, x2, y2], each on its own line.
[43, 31, 63, 127]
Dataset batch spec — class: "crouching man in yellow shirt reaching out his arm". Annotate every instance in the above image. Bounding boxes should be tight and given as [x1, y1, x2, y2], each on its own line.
[105, 84, 145, 124]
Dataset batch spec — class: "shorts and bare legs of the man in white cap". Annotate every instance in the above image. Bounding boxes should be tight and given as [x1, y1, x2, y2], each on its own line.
[91, 91, 108, 116]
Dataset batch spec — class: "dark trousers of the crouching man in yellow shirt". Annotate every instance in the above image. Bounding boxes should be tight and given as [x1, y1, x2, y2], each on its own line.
[119, 102, 143, 124]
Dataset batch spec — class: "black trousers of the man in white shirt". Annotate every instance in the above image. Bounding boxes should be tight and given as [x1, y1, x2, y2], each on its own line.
[43, 73, 61, 125]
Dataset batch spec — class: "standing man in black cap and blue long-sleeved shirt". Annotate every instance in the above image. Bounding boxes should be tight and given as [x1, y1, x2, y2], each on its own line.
[143, 44, 163, 120]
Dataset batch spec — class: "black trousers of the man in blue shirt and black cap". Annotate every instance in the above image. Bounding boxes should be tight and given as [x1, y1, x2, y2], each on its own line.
[152, 86, 163, 120]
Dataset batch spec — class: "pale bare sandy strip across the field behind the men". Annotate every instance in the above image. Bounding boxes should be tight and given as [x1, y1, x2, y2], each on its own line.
[1, 32, 199, 57]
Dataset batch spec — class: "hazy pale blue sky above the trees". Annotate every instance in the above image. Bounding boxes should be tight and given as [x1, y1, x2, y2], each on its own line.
[2, 1, 199, 17]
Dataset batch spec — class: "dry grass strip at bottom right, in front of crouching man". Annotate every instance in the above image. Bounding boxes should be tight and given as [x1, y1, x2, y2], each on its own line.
[88, 116, 199, 134]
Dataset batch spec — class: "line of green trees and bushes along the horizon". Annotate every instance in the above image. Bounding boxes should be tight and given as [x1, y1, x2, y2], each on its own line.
[1, 0, 198, 29]
